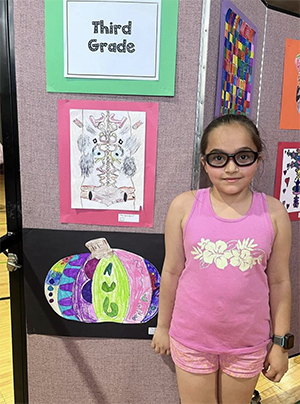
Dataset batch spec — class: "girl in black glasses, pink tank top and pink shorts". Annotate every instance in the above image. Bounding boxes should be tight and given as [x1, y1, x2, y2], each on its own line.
[152, 115, 293, 404]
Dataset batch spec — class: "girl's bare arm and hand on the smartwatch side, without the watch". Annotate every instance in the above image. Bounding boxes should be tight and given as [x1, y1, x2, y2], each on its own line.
[263, 197, 291, 382]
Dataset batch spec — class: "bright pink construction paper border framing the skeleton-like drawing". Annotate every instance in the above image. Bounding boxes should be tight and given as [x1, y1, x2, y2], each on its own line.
[58, 100, 158, 227]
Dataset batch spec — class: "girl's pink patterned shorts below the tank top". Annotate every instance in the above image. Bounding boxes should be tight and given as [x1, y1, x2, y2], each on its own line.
[170, 337, 267, 378]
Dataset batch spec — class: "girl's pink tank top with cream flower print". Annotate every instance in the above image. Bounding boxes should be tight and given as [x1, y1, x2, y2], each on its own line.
[170, 188, 274, 354]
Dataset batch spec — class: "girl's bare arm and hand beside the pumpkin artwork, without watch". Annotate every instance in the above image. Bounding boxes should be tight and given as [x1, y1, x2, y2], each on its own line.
[151, 193, 194, 355]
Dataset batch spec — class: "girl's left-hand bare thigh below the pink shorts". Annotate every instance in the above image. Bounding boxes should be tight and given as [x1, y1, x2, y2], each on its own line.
[176, 365, 217, 404]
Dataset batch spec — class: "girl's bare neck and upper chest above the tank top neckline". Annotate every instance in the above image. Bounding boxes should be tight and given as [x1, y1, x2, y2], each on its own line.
[210, 187, 253, 219]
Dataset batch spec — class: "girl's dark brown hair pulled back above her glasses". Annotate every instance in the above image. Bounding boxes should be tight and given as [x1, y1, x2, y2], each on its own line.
[200, 114, 264, 155]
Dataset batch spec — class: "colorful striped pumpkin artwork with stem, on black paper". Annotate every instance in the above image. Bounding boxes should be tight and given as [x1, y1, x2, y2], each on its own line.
[45, 238, 160, 324]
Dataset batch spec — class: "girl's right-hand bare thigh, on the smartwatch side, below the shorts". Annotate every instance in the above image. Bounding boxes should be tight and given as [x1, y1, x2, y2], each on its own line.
[219, 370, 259, 404]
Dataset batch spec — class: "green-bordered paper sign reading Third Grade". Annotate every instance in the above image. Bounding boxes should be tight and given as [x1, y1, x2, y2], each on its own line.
[45, 0, 178, 96]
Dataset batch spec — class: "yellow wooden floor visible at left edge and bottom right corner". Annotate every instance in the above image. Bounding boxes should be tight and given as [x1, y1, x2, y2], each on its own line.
[0, 174, 300, 404]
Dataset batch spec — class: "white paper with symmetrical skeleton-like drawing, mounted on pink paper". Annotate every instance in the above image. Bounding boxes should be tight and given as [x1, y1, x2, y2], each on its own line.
[70, 110, 145, 210]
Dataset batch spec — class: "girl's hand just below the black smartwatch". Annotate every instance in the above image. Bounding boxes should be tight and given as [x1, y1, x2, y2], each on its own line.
[263, 344, 289, 383]
